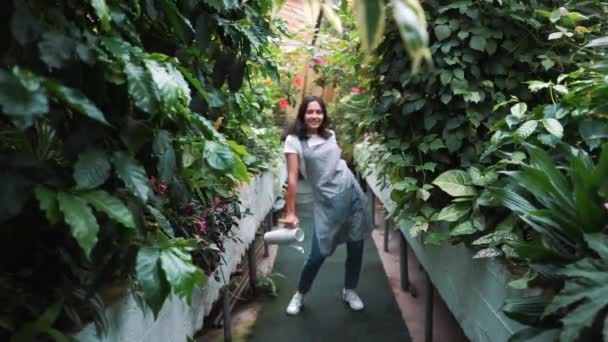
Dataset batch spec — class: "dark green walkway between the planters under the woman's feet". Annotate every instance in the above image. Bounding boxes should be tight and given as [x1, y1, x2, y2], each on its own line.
[249, 203, 411, 342]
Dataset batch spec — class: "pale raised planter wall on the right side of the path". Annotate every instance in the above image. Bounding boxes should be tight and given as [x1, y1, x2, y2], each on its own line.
[355, 145, 525, 342]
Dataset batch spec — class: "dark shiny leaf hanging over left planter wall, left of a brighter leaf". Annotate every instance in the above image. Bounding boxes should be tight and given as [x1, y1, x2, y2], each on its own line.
[135, 247, 169, 318]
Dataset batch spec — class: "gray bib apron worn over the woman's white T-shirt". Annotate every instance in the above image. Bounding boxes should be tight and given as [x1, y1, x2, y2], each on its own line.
[301, 135, 373, 256]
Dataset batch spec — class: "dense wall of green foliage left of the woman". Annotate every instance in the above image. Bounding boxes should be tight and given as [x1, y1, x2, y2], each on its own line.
[0, 0, 283, 341]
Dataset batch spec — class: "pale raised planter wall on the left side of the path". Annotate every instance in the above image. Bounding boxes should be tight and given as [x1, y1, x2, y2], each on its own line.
[75, 162, 286, 342]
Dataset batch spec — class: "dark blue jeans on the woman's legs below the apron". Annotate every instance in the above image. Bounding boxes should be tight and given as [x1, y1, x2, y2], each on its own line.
[298, 228, 363, 294]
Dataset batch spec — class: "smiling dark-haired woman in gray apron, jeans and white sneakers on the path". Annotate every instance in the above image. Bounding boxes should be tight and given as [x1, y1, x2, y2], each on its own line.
[280, 95, 372, 315]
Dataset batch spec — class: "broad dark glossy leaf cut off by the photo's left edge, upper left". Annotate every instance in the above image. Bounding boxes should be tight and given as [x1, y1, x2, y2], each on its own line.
[0, 68, 49, 128]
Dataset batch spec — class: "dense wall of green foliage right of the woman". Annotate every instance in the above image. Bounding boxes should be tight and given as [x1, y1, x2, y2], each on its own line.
[352, 0, 608, 341]
